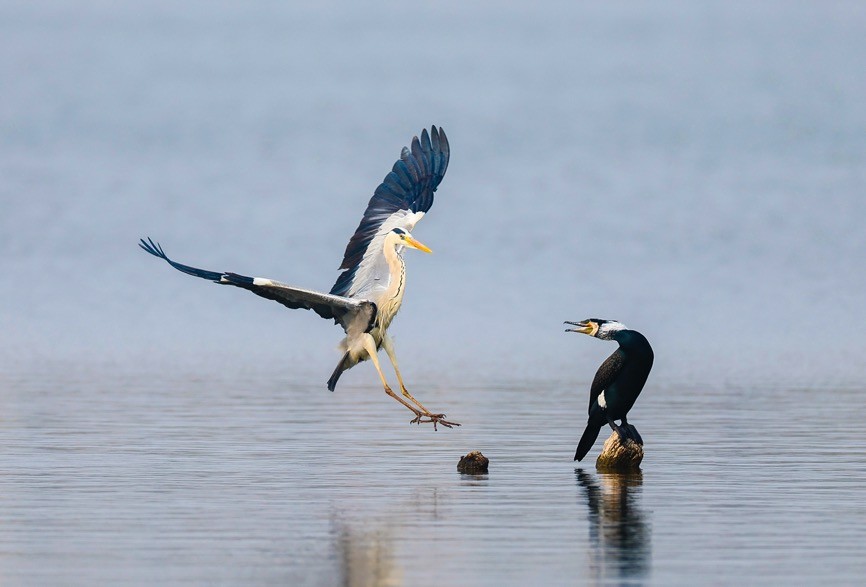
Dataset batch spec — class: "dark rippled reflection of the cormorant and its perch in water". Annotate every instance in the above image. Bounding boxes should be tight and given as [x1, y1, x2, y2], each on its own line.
[574, 469, 652, 578]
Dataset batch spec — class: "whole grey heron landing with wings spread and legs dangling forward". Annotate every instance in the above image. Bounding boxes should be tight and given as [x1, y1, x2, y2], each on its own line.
[139, 126, 459, 429]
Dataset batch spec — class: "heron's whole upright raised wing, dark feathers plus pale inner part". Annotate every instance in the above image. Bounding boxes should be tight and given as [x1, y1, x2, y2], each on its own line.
[331, 126, 451, 298]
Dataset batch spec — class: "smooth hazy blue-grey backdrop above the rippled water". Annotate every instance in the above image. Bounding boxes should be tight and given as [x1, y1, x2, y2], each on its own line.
[0, 2, 866, 387]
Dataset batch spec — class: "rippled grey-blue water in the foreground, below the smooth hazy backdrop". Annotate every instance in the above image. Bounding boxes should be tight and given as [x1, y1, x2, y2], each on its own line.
[0, 377, 866, 585]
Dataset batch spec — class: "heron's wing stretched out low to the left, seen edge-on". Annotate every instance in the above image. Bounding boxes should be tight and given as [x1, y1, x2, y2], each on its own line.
[138, 238, 376, 335]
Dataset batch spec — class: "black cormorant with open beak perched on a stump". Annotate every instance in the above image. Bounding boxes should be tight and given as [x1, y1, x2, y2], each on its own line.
[566, 318, 653, 461]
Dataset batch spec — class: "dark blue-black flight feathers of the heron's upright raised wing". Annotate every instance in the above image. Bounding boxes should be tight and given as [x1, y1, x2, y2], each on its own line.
[331, 126, 451, 295]
